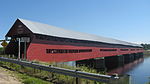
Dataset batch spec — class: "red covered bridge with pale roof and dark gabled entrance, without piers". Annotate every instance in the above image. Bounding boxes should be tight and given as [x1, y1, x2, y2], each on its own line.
[6, 19, 143, 62]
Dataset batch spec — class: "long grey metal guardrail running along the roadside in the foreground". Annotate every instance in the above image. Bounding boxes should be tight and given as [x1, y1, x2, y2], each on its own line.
[0, 57, 119, 83]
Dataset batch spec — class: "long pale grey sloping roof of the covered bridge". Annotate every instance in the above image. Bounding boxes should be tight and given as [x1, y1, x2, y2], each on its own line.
[7, 19, 141, 47]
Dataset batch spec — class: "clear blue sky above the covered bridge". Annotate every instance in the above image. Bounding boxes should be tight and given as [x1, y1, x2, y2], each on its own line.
[0, 0, 150, 43]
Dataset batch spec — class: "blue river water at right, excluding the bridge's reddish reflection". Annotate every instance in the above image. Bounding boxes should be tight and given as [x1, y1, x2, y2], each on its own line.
[126, 57, 150, 84]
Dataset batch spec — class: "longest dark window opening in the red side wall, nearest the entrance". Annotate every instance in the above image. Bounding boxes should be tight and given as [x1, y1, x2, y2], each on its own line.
[46, 49, 92, 53]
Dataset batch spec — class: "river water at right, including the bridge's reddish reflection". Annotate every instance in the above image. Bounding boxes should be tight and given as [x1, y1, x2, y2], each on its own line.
[109, 56, 150, 84]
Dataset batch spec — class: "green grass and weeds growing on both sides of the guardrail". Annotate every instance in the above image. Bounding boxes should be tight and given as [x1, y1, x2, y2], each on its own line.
[0, 57, 104, 84]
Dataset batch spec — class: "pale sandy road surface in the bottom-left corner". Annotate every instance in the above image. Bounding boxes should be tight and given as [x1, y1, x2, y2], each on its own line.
[0, 67, 22, 84]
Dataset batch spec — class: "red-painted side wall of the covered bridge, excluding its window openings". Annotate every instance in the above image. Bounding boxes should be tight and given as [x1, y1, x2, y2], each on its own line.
[27, 43, 143, 62]
